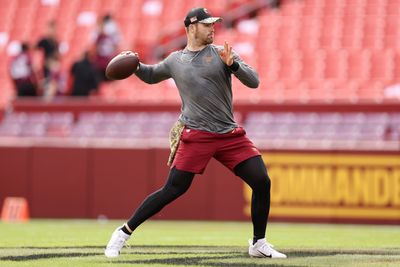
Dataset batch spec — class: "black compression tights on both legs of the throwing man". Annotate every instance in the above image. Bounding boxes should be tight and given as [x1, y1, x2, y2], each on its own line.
[127, 156, 271, 239]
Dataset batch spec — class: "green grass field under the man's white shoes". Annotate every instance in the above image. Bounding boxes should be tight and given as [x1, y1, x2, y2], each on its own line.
[0, 220, 400, 267]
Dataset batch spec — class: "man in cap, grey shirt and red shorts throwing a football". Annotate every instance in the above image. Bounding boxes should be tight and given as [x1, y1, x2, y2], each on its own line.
[105, 8, 286, 258]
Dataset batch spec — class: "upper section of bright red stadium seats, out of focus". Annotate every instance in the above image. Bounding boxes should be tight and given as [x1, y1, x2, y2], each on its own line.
[0, 0, 400, 106]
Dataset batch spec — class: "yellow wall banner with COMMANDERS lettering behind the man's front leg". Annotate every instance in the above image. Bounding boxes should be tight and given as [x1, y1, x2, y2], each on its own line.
[245, 153, 400, 221]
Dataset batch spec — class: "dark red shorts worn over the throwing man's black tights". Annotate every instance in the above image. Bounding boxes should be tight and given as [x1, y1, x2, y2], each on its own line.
[171, 127, 260, 173]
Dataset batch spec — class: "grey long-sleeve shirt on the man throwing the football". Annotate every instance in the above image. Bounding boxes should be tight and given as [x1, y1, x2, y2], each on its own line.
[135, 44, 259, 133]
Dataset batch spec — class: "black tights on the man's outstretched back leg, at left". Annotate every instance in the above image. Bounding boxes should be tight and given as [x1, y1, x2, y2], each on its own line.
[127, 167, 194, 231]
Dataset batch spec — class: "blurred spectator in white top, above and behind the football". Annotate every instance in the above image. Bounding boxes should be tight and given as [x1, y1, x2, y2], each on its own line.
[93, 14, 121, 81]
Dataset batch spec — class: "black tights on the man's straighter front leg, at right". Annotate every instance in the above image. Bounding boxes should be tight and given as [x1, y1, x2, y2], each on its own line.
[234, 156, 271, 240]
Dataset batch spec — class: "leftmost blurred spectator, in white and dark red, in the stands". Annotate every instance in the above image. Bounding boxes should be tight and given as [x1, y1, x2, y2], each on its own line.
[9, 43, 37, 96]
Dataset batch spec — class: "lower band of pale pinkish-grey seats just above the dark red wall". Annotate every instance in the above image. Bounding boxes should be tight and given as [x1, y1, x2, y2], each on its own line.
[0, 112, 400, 151]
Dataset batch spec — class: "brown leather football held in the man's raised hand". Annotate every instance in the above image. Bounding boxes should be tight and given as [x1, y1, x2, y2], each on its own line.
[106, 51, 139, 80]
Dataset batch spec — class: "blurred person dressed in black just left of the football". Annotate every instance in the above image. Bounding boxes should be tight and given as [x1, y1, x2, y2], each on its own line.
[70, 51, 99, 96]
